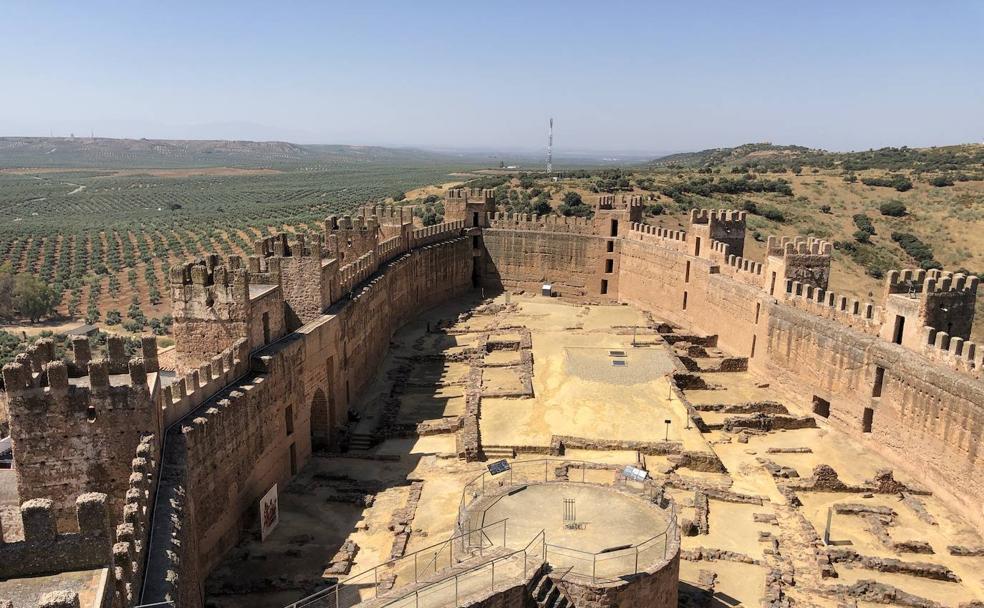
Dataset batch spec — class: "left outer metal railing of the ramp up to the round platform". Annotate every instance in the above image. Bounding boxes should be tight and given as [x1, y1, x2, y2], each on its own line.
[287, 519, 508, 608]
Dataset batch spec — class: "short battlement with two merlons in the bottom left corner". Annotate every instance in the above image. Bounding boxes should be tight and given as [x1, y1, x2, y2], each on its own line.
[0, 492, 113, 580]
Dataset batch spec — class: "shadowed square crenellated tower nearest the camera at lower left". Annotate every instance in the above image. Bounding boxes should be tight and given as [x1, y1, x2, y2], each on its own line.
[3, 338, 160, 528]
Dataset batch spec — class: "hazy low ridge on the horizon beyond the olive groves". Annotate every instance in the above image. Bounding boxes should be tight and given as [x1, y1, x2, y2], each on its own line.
[0, 137, 462, 168]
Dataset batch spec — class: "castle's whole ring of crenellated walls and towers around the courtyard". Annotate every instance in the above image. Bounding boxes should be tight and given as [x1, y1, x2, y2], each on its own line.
[0, 190, 984, 608]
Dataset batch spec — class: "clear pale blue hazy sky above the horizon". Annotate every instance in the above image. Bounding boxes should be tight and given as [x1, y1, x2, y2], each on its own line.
[0, 0, 984, 152]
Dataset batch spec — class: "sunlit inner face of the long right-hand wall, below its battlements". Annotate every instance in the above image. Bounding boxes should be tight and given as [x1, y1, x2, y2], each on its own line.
[619, 228, 984, 528]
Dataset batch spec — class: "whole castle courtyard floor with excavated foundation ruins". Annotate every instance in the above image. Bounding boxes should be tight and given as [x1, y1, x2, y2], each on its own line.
[205, 292, 984, 608]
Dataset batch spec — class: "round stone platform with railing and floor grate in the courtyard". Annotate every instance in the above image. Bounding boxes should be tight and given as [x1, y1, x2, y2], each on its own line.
[458, 472, 680, 608]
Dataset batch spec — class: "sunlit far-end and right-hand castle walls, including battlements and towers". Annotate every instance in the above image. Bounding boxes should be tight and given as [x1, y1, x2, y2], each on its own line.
[485, 209, 984, 528]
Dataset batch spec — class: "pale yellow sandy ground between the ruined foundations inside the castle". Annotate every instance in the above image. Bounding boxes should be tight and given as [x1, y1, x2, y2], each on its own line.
[207, 297, 984, 608]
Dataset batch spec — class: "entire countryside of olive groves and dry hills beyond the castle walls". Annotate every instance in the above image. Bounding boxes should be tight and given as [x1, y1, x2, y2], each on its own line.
[0, 144, 984, 358]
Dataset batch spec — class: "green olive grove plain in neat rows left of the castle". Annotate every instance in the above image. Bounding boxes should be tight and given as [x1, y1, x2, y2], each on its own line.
[0, 158, 472, 338]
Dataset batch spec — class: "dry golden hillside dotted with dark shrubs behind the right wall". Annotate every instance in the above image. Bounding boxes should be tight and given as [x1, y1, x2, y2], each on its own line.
[444, 145, 984, 341]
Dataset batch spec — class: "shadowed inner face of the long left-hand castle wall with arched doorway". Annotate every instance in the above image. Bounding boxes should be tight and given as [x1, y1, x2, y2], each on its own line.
[144, 237, 472, 607]
